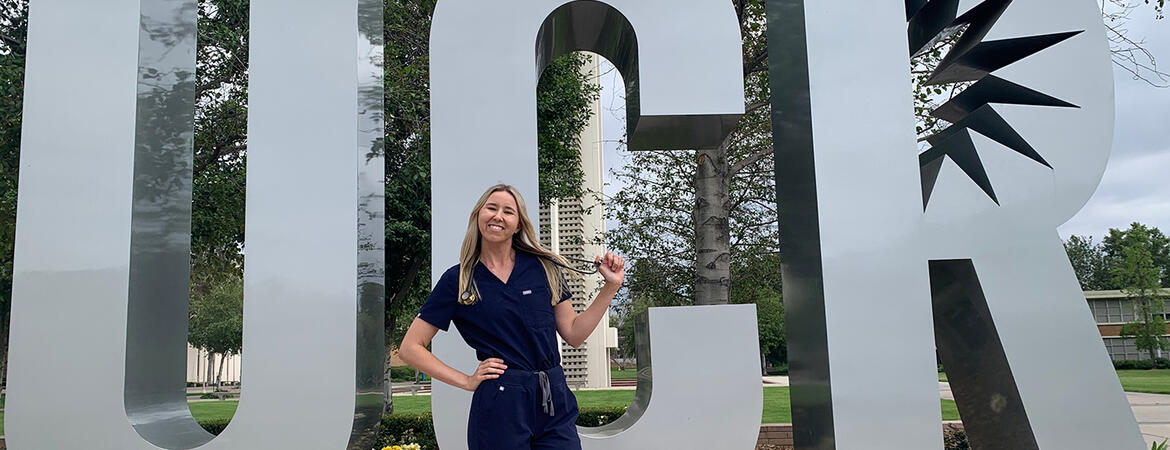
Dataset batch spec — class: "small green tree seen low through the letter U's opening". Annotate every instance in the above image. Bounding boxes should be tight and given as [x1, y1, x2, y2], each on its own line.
[187, 278, 243, 385]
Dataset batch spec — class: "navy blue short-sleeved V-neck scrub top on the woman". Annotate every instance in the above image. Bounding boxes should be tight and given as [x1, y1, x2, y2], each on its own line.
[418, 250, 572, 371]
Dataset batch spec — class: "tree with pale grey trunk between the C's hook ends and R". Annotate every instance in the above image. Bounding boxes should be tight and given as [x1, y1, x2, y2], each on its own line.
[606, 0, 779, 305]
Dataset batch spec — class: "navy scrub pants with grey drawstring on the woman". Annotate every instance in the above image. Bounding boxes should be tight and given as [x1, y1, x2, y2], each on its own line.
[467, 366, 581, 450]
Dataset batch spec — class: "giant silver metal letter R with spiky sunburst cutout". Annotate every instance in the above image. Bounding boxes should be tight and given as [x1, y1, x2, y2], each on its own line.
[766, 0, 1142, 450]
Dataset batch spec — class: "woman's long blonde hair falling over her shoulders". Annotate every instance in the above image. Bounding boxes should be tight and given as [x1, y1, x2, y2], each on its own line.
[459, 185, 569, 306]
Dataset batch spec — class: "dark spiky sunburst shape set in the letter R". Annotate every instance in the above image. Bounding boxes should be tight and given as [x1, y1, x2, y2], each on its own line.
[906, 0, 1083, 209]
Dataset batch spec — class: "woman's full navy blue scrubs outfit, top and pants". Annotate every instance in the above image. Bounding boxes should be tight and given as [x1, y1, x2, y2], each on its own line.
[418, 250, 580, 450]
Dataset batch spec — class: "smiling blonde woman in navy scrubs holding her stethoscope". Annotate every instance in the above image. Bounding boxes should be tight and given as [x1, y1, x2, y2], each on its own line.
[399, 185, 626, 450]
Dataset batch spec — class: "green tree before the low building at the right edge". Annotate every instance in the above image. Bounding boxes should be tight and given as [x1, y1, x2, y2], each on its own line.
[1114, 244, 1170, 360]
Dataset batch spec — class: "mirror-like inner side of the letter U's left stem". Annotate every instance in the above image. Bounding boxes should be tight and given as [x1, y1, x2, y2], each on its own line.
[124, 0, 213, 449]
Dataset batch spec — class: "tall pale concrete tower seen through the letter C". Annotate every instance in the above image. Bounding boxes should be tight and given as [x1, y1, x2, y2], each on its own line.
[541, 54, 618, 388]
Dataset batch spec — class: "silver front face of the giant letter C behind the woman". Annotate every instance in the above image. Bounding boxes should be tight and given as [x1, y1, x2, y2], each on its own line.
[431, 0, 761, 449]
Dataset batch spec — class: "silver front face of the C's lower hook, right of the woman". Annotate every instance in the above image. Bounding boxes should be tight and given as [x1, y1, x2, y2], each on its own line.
[579, 305, 763, 449]
